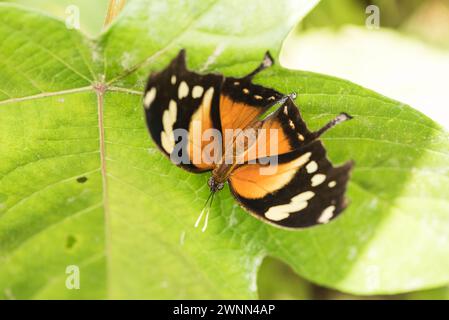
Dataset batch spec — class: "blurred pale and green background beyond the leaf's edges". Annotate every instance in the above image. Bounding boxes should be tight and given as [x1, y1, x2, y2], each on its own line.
[0, 0, 449, 299]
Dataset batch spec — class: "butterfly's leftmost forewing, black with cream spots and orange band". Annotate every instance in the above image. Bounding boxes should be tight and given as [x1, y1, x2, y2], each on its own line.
[143, 50, 223, 172]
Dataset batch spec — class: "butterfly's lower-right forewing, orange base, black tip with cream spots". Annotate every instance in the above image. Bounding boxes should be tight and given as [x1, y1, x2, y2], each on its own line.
[229, 140, 352, 228]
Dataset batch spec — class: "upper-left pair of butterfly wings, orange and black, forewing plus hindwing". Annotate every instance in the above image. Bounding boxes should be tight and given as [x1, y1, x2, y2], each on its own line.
[144, 50, 282, 172]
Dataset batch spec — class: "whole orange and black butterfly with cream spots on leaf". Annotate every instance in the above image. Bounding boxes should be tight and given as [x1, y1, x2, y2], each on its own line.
[143, 50, 354, 231]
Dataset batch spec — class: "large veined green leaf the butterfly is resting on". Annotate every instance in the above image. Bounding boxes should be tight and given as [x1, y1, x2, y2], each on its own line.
[0, 0, 449, 298]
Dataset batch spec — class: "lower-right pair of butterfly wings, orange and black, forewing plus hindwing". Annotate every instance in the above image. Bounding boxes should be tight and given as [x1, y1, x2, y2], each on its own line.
[229, 100, 353, 228]
